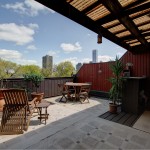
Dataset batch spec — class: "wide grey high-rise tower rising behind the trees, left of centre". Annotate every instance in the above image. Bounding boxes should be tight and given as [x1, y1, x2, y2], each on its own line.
[42, 55, 53, 70]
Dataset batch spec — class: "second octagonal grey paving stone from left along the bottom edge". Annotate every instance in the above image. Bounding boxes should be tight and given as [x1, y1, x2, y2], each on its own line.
[82, 136, 98, 148]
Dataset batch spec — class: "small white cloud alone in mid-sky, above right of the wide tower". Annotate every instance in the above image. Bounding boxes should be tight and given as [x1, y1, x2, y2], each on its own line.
[60, 42, 82, 53]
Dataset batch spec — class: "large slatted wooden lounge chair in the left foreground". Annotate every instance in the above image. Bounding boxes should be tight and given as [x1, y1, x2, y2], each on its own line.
[0, 89, 37, 134]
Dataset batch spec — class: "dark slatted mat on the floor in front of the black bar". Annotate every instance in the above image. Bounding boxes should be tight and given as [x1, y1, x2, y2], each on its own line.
[99, 111, 140, 127]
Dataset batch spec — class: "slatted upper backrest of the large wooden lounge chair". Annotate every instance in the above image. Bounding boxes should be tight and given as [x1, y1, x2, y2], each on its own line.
[2, 89, 28, 105]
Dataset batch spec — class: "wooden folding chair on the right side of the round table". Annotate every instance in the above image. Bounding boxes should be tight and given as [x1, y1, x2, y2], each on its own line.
[79, 84, 91, 103]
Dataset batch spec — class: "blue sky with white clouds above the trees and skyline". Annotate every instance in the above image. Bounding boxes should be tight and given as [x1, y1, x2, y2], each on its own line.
[0, 0, 126, 67]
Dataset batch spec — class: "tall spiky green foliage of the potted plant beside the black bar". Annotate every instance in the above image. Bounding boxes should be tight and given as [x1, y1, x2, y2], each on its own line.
[109, 56, 124, 104]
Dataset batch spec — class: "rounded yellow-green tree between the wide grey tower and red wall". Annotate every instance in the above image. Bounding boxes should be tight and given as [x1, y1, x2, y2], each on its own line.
[54, 61, 75, 77]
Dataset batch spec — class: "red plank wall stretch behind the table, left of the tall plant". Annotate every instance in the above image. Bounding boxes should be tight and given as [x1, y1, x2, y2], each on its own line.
[77, 62, 112, 92]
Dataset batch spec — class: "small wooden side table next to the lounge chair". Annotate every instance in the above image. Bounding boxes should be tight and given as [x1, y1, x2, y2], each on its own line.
[36, 100, 50, 125]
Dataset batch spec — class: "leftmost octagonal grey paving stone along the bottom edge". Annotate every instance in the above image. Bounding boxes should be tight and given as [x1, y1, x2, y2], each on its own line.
[57, 138, 75, 149]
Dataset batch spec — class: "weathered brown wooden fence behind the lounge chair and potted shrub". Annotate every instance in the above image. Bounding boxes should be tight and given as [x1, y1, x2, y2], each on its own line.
[1, 77, 73, 98]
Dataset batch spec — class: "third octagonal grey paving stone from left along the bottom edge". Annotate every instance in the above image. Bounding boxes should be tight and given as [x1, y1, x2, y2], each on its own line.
[107, 135, 123, 147]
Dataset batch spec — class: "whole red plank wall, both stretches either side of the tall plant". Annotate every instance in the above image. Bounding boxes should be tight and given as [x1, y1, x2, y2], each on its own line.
[77, 51, 150, 92]
